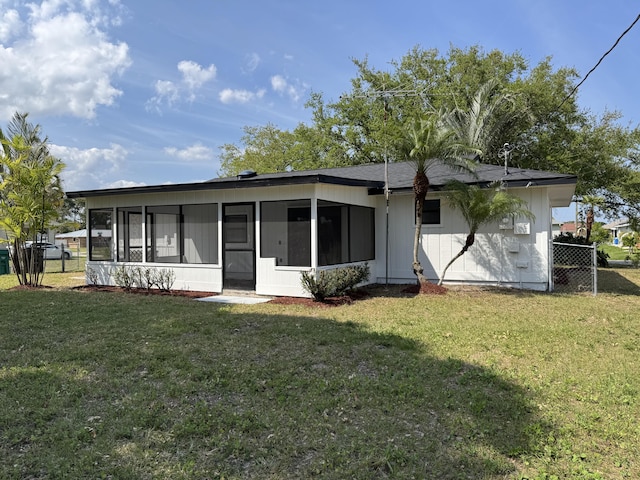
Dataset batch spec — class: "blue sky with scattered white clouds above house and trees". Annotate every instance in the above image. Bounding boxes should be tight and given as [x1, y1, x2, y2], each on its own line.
[0, 0, 640, 219]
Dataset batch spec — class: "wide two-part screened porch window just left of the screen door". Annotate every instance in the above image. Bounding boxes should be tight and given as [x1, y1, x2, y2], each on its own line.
[146, 203, 218, 264]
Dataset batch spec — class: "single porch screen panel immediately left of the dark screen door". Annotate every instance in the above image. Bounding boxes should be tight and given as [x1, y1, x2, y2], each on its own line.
[182, 203, 218, 263]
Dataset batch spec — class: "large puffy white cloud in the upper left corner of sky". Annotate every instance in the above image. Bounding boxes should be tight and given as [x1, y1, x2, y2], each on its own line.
[0, 0, 131, 119]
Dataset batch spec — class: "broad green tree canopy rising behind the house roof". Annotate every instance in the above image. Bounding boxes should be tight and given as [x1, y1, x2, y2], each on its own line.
[221, 46, 640, 217]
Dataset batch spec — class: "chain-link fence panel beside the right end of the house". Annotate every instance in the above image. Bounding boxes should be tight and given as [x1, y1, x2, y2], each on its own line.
[552, 242, 598, 295]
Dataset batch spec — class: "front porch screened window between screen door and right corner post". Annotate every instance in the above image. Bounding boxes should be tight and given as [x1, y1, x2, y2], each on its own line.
[260, 200, 311, 267]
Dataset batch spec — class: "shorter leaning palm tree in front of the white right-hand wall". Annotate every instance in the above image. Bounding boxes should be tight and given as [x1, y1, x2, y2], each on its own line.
[438, 181, 535, 285]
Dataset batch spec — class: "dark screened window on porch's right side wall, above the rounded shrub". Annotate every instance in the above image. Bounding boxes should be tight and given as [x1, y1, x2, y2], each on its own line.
[318, 200, 375, 266]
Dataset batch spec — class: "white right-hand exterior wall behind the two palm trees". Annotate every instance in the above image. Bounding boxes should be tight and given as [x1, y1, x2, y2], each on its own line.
[376, 187, 551, 290]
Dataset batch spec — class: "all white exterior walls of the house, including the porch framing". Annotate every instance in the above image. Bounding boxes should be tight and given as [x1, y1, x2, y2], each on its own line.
[87, 184, 551, 296]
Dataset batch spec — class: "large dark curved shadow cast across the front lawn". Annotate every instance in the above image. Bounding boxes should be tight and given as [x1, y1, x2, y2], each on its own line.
[0, 292, 551, 479]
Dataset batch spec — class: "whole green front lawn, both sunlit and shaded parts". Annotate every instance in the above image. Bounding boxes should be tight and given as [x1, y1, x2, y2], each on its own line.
[0, 269, 640, 480]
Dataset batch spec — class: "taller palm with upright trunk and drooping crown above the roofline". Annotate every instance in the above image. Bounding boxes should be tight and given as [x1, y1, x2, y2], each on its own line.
[404, 112, 478, 287]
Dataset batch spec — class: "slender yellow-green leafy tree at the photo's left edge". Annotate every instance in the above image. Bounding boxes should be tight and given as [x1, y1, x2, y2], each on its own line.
[0, 113, 64, 286]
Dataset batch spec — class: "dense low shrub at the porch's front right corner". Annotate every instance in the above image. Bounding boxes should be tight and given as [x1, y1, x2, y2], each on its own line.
[300, 264, 370, 302]
